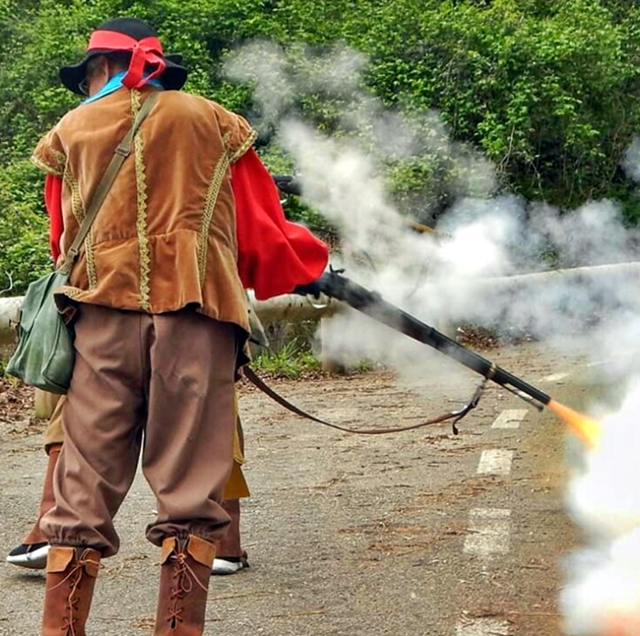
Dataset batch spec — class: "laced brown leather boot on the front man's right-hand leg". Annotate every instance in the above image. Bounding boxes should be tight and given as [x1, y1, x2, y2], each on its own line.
[153, 535, 216, 636]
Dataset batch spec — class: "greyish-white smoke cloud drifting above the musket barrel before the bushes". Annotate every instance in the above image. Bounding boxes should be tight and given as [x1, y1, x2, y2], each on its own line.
[226, 43, 640, 367]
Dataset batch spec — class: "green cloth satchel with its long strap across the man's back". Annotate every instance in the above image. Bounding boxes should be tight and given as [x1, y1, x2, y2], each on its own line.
[6, 91, 158, 393]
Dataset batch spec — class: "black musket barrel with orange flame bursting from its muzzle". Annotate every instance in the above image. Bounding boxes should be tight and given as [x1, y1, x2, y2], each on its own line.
[313, 270, 600, 447]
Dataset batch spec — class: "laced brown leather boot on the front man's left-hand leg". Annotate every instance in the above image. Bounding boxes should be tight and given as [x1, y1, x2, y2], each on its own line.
[42, 546, 100, 636]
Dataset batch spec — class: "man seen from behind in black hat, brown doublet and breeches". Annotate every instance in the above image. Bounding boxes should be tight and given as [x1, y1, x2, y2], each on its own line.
[33, 18, 328, 636]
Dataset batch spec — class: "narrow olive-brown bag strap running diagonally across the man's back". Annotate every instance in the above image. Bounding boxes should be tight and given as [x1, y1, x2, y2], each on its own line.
[60, 91, 160, 274]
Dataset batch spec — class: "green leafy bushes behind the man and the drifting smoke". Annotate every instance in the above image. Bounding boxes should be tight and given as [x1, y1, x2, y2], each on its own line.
[0, 0, 640, 291]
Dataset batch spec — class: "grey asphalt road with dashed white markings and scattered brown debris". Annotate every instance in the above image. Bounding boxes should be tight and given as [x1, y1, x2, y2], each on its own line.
[0, 344, 612, 636]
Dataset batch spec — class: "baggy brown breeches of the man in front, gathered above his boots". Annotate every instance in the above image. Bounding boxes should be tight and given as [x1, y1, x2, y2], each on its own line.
[41, 305, 237, 556]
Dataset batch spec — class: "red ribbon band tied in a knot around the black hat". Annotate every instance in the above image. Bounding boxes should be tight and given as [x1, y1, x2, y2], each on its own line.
[87, 31, 167, 89]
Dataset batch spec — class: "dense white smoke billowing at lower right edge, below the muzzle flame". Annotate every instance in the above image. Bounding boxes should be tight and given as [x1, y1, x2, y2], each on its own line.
[560, 378, 640, 636]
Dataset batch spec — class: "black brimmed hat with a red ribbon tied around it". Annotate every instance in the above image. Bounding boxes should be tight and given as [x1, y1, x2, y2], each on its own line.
[60, 18, 188, 95]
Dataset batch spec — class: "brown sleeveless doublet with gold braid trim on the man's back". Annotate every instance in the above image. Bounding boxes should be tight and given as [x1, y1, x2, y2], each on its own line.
[32, 87, 255, 331]
